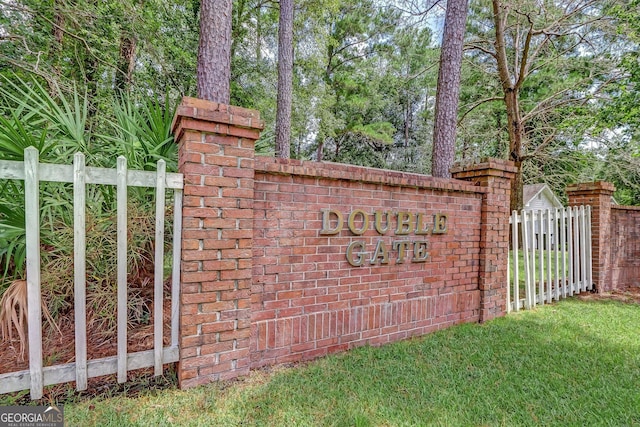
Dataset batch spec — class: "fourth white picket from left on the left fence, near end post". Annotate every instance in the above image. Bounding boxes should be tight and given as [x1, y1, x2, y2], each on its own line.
[153, 160, 166, 376]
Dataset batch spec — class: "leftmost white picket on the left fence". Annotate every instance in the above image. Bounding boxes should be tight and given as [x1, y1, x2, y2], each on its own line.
[24, 147, 43, 400]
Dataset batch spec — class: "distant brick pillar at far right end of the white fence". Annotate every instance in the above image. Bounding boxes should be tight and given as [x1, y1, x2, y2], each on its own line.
[567, 181, 616, 292]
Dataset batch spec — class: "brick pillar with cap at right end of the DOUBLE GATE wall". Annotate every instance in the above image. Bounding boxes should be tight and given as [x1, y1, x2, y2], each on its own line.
[451, 159, 517, 322]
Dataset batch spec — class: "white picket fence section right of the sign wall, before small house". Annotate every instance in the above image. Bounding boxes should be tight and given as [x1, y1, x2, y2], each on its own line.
[507, 206, 593, 312]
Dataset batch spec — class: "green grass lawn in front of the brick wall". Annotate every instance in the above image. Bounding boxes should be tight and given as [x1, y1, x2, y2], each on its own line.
[65, 299, 640, 426]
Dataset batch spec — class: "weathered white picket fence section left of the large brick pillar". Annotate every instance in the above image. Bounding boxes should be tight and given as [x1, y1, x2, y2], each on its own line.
[0, 147, 183, 399]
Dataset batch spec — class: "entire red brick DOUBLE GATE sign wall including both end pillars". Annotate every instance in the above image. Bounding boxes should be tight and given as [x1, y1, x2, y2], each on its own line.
[174, 98, 514, 387]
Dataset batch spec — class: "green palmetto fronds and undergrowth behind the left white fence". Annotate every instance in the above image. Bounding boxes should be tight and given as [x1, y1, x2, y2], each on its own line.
[0, 76, 177, 350]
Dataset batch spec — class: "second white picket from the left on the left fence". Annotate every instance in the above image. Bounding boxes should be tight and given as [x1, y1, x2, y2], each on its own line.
[73, 153, 87, 391]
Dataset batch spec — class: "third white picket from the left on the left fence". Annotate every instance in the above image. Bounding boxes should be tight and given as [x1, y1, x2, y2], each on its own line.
[116, 156, 128, 383]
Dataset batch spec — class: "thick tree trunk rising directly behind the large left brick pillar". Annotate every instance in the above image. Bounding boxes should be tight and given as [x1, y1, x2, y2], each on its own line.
[197, 0, 232, 104]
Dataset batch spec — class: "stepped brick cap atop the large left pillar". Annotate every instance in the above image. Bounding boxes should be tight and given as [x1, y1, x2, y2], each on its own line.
[171, 96, 264, 141]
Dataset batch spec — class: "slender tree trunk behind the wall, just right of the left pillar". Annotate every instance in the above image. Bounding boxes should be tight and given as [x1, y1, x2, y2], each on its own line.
[276, 0, 293, 159]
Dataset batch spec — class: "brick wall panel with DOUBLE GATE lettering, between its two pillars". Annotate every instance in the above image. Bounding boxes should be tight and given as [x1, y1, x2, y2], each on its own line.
[251, 159, 483, 366]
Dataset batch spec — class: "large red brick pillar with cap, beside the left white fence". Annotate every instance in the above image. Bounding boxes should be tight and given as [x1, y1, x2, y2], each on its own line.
[173, 98, 263, 388]
